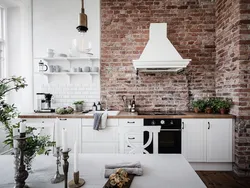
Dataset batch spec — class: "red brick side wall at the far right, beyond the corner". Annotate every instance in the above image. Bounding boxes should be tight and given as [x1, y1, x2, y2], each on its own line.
[215, 0, 250, 176]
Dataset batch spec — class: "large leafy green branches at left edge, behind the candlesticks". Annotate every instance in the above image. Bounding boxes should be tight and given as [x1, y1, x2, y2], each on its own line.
[0, 76, 55, 170]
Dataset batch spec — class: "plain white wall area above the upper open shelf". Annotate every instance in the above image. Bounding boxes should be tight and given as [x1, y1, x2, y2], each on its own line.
[33, 0, 100, 57]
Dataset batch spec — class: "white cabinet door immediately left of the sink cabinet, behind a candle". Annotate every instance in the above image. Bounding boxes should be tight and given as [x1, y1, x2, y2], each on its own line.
[56, 118, 81, 150]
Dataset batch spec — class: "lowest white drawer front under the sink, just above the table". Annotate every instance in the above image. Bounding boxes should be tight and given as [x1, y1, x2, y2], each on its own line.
[82, 142, 118, 153]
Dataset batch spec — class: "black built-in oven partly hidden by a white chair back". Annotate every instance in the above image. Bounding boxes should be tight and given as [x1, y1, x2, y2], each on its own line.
[143, 119, 181, 153]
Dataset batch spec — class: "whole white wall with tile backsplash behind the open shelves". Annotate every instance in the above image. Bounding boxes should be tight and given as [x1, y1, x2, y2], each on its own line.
[33, 0, 100, 109]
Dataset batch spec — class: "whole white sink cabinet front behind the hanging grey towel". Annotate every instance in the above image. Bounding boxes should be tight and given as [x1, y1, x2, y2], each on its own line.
[80, 118, 119, 153]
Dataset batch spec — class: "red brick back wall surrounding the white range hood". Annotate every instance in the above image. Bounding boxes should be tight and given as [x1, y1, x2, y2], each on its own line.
[101, 0, 215, 110]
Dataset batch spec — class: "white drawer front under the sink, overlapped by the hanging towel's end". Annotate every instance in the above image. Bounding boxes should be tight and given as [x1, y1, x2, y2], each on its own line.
[81, 126, 118, 142]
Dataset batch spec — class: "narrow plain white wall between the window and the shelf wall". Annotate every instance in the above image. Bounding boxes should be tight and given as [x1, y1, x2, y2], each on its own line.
[2, 0, 33, 112]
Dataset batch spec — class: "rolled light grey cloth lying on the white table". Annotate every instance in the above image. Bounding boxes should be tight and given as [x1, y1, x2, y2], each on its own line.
[104, 161, 143, 178]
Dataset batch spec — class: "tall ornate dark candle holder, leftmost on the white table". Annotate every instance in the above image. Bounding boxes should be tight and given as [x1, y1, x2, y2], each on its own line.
[14, 134, 29, 188]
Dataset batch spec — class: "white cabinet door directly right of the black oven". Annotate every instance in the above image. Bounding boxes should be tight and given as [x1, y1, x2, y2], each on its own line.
[182, 119, 206, 162]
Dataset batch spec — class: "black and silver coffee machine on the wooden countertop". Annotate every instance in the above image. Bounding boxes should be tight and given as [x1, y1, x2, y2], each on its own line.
[35, 93, 55, 113]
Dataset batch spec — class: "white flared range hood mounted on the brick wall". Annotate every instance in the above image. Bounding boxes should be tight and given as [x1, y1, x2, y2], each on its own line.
[133, 23, 191, 72]
